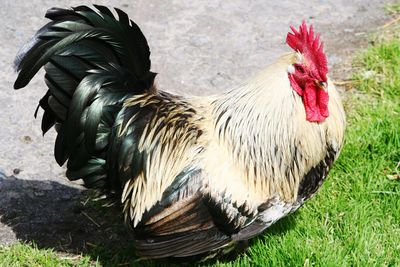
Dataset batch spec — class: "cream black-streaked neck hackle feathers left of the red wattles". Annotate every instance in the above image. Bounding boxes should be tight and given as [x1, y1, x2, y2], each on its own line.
[212, 54, 336, 201]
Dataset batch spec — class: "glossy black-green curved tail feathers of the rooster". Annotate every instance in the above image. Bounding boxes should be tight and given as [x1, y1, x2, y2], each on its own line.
[14, 5, 156, 187]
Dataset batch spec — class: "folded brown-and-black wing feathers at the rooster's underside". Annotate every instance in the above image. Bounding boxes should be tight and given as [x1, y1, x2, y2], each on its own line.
[134, 195, 231, 258]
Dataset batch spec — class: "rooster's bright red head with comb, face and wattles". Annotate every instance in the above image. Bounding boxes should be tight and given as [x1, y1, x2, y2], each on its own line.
[286, 22, 329, 122]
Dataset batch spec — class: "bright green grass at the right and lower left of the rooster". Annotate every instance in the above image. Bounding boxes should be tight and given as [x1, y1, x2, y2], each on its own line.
[0, 11, 400, 267]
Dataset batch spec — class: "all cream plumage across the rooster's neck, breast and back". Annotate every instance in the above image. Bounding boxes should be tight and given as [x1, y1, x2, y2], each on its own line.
[122, 53, 345, 225]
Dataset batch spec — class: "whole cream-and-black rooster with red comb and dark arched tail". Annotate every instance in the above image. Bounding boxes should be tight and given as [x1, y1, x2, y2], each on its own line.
[14, 5, 345, 258]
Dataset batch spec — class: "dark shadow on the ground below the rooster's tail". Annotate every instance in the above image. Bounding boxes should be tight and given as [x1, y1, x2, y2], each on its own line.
[0, 176, 142, 266]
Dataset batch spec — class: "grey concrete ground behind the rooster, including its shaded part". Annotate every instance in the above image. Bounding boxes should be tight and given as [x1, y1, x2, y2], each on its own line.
[0, 0, 394, 260]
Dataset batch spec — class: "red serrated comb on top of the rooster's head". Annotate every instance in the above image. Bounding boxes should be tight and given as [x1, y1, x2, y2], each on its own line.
[286, 21, 328, 82]
